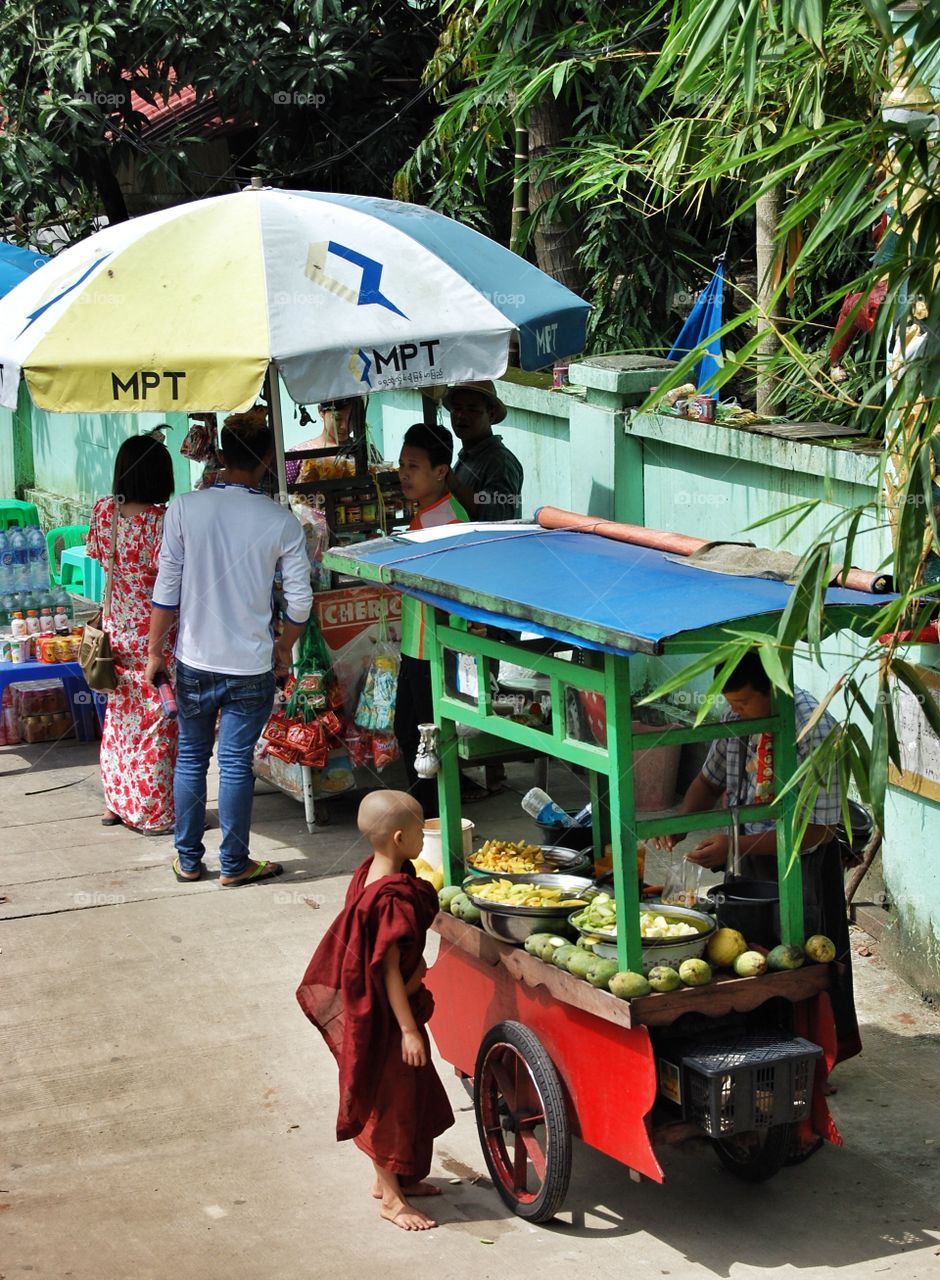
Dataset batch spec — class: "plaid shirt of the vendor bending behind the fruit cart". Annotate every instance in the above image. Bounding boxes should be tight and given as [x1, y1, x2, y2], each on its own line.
[702, 689, 841, 832]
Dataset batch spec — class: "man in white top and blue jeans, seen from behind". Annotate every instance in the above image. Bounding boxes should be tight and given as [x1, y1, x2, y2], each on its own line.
[146, 415, 312, 887]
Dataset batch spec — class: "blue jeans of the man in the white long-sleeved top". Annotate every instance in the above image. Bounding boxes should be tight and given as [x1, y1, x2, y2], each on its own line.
[173, 662, 274, 876]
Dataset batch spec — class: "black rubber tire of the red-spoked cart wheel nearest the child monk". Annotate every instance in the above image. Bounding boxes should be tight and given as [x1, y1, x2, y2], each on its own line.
[474, 1021, 571, 1222]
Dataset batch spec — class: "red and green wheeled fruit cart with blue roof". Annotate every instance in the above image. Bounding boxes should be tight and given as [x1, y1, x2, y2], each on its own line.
[328, 524, 873, 1221]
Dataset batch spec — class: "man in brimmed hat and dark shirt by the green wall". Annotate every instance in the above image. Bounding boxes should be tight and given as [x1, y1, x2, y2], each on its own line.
[444, 381, 523, 520]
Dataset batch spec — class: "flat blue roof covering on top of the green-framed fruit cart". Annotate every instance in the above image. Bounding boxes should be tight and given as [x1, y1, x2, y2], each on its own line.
[327, 525, 885, 653]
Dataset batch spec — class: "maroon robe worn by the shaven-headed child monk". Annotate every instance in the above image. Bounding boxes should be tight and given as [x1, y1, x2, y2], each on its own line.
[297, 858, 453, 1181]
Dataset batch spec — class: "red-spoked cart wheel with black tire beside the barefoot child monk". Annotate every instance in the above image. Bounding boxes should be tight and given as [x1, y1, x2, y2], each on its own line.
[474, 1021, 571, 1222]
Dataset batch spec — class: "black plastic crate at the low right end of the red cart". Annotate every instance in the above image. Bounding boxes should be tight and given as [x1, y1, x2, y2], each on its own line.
[681, 1033, 822, 1138]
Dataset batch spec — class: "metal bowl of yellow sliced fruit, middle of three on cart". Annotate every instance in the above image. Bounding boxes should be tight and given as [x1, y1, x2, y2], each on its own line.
[464, 872, 593, 943]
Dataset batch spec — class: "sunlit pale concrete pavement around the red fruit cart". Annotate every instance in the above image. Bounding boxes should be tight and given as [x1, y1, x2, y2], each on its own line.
[0, 744, 940, 1280]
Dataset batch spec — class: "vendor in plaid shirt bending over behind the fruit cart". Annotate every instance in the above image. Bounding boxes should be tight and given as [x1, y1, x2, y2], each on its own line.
[654, 649, 862, 1061]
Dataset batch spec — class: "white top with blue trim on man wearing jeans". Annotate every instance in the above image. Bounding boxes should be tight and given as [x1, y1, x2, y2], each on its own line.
[154, 484, 312, 676]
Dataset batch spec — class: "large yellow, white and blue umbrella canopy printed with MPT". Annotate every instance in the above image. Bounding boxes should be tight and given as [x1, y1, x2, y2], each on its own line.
[0, 189, 589, 412]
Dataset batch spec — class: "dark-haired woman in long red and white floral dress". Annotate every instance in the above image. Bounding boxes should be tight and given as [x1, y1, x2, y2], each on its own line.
[86, 435, 177, 836]
